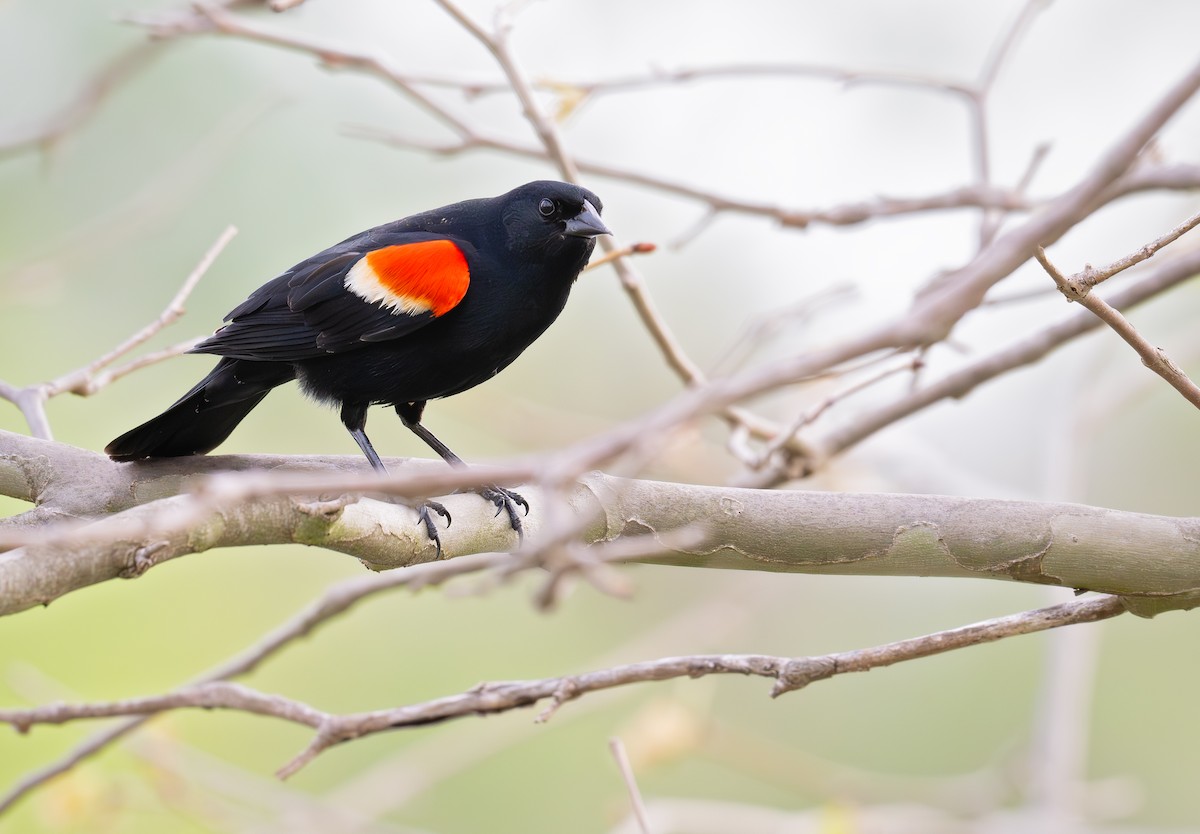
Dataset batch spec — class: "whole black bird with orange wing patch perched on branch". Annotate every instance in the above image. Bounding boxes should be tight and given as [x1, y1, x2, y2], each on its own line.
[104, 181, 610, 550]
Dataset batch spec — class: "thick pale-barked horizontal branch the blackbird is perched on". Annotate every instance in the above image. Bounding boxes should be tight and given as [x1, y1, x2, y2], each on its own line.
[0, 444, 1200, 614]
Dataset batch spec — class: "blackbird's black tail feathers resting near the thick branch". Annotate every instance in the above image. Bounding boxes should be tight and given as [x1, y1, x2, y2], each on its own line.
[104, 359, 295, 461]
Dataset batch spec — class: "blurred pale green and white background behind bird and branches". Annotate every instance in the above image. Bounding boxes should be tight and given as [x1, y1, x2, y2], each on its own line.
[0, 0, 1200, 834]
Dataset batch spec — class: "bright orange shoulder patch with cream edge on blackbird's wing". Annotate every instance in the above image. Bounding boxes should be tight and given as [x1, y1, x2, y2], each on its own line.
[346, 240, 470, 316]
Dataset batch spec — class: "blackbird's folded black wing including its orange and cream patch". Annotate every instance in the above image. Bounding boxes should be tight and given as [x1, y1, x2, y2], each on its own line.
[193, 234, 474, 362]
